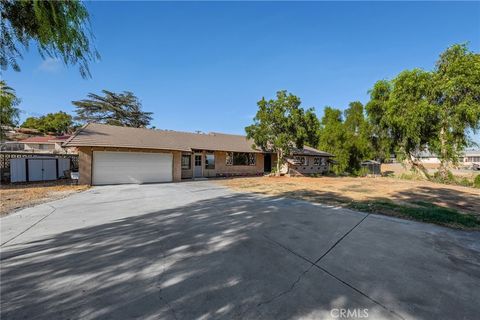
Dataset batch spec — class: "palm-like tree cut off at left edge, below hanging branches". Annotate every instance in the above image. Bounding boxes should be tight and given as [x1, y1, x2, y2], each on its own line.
[0, 80, 20, 141]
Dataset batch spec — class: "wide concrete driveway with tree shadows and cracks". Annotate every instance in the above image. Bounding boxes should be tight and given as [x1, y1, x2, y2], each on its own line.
[0, 181, 480, 319]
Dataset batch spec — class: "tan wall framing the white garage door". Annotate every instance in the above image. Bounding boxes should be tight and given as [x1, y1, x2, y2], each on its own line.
[78, 147, 182, 185]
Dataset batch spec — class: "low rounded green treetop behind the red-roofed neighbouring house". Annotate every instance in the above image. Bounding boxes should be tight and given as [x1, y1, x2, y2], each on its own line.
[21, 111, 73, 135]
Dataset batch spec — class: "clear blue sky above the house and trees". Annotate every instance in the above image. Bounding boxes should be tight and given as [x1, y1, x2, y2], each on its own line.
[2, 2, 480, 140]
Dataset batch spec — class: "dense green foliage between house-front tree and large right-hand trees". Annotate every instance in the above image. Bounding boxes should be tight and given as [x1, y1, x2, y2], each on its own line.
[318, 101, 373, 175]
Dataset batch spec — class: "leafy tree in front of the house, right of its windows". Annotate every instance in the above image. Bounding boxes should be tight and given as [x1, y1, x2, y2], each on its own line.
[245, 90, 318, 175]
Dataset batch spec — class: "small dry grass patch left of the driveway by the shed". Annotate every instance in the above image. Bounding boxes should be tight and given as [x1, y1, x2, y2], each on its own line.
[0, 183, 89, 215]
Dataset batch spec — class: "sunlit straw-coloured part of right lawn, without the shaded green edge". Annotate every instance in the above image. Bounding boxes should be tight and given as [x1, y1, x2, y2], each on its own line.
[217, 177, 480, 216]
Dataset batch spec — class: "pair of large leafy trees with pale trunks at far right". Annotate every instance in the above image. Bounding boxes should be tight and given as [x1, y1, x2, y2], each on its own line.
[366, 45, 480, 179]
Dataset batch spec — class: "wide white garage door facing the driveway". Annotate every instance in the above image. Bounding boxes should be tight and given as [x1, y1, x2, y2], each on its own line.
[92, 151, 173, 185]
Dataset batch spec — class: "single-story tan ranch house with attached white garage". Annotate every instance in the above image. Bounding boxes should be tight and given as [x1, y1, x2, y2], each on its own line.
[63, 123, 332, 185]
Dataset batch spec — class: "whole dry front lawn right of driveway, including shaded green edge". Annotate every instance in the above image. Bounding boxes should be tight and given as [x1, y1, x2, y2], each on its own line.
[217, 177, 480, 230]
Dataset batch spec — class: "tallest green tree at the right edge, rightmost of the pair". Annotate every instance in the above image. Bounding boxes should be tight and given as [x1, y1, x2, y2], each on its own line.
[429, 44, 480, 177]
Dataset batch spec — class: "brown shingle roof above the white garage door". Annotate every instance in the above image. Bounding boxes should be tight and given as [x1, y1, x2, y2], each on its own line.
[63, 123, 261, 152]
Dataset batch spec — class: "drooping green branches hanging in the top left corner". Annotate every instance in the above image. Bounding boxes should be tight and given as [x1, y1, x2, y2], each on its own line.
[0, 0, 100, 78]
